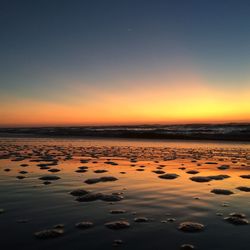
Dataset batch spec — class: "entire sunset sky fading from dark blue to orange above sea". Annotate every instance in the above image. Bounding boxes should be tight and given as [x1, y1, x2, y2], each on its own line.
[0, 0, 250, 126]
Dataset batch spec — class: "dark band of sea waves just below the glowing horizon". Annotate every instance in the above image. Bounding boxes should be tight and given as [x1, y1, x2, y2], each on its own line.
[0, 123, 250, 142]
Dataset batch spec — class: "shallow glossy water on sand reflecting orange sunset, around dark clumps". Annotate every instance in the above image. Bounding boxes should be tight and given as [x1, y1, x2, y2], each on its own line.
[0, 138, 250, 250]
